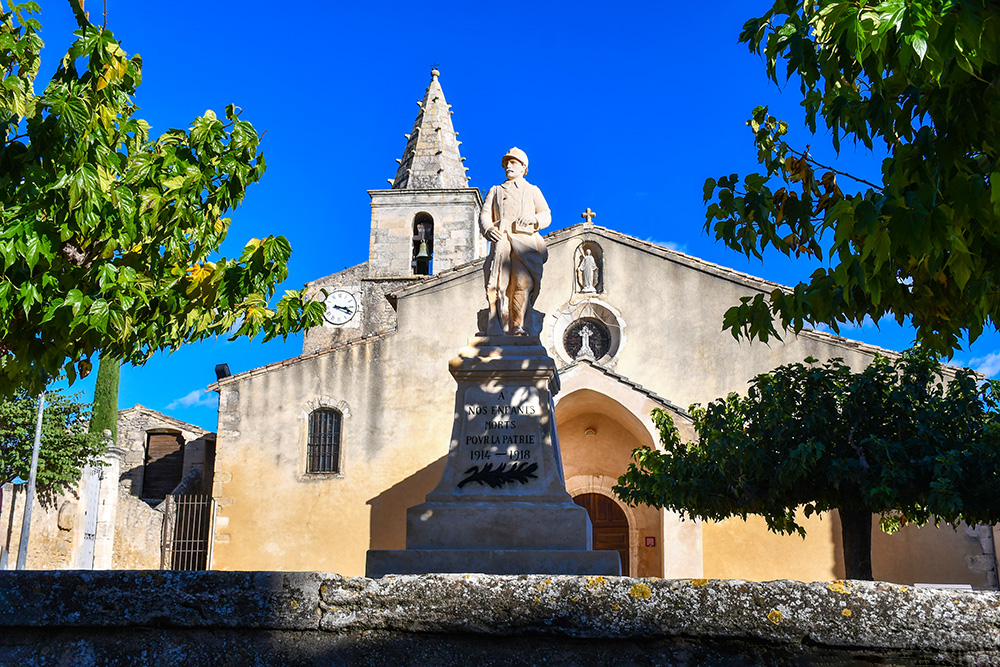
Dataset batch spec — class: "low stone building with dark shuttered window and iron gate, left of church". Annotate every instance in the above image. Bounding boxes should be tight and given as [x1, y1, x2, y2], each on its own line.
[0, 405, 215, 570]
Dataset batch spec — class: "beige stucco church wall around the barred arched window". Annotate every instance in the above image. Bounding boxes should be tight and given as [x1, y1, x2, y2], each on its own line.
[213, 328, 464, 573]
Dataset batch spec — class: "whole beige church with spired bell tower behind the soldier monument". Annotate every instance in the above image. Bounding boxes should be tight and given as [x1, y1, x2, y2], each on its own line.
[210, 71, 996, 588]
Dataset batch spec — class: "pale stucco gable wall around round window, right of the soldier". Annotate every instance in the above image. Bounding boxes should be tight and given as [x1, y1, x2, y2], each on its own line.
[536, 228, 871, 409]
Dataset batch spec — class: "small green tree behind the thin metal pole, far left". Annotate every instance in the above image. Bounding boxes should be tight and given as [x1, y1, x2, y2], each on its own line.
[0, 391, 104, 499]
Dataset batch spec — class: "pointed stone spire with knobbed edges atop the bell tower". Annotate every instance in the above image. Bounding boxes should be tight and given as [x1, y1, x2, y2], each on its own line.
[392, 69, 469, 190]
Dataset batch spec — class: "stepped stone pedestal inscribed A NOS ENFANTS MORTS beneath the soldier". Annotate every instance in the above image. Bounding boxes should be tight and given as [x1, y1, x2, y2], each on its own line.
[366, 336, 621, 577]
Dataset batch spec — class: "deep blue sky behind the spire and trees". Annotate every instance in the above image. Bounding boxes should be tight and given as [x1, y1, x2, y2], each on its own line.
[31, 0, 1000, 430]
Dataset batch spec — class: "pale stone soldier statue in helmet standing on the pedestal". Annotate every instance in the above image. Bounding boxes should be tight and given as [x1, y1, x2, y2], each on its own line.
[479, 148, 552, 336]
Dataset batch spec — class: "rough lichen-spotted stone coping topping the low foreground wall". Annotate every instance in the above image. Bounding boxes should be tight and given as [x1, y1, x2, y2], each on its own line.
[0, 571, 1000, 656]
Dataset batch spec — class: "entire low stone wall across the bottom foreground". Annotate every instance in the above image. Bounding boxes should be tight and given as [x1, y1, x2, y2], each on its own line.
[0, 572, 1000, 667]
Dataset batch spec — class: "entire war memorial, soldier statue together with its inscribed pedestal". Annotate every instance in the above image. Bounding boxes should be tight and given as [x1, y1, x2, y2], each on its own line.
[365, 148, 622, 578]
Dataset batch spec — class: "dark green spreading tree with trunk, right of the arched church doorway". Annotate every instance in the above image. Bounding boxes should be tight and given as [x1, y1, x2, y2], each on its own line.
[615, 352, 1000, 579]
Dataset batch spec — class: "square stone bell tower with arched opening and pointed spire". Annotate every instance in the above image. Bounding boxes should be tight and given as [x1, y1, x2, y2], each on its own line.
[368, 69, 486, 278]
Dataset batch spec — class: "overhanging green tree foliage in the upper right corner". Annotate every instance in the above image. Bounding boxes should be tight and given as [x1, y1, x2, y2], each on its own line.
[705, 0, 1000, 354]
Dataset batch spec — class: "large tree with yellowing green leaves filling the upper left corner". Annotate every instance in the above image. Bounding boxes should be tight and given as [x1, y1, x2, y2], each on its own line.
[0, 0, 322, 396]
